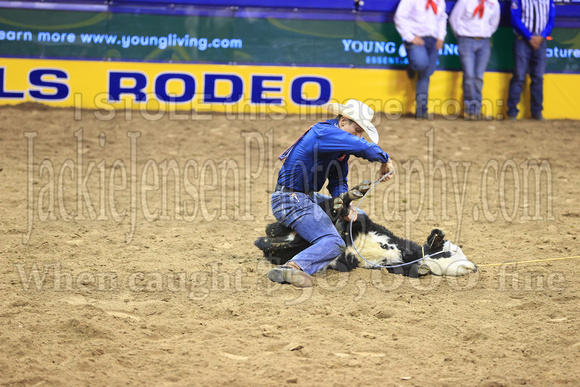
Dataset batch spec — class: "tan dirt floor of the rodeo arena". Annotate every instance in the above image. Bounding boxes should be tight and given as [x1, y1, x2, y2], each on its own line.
[0, 105, 580, 386]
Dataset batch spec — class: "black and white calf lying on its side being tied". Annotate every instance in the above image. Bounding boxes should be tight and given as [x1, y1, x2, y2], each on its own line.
[254, 181, 477, 277]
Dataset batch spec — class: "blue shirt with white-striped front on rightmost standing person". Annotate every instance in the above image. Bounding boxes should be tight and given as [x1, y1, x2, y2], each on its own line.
[510, 0, 556, 40]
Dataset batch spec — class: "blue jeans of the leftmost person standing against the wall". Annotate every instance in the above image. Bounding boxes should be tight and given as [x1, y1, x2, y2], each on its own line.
[405, 36, 439, 118]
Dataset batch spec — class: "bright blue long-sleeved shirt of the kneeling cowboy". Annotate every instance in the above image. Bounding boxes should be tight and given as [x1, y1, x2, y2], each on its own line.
[278, 119, 389, 197]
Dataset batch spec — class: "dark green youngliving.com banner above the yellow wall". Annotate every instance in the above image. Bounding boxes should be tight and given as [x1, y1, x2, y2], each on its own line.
[0, 9, 580, 72]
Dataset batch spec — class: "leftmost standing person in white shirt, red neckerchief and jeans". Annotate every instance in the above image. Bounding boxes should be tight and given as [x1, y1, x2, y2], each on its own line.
[394, 0, 447, 118]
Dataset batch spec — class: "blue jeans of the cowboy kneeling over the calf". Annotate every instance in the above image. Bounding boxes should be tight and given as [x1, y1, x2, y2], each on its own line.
[271, 191, 345, 274]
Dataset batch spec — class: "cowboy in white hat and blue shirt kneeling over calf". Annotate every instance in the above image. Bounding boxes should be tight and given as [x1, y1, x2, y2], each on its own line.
[268, 99, 393, 287]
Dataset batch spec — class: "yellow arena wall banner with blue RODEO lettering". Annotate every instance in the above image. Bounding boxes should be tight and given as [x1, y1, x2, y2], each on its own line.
[0, 59, 580, 120]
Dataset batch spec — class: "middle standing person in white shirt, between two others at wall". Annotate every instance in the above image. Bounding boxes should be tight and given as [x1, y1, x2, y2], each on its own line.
[449, 0, 500, 120]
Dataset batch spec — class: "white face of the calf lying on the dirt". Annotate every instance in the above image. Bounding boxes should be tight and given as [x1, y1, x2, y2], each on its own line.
[419, 241, 477, 277]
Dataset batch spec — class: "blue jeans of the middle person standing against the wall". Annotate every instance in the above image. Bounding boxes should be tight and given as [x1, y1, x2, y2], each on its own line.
[457, 36, 491, 115]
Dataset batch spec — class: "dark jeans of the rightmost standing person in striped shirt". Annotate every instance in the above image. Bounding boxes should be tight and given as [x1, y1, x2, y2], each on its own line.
[507, 38, 547, 117]
